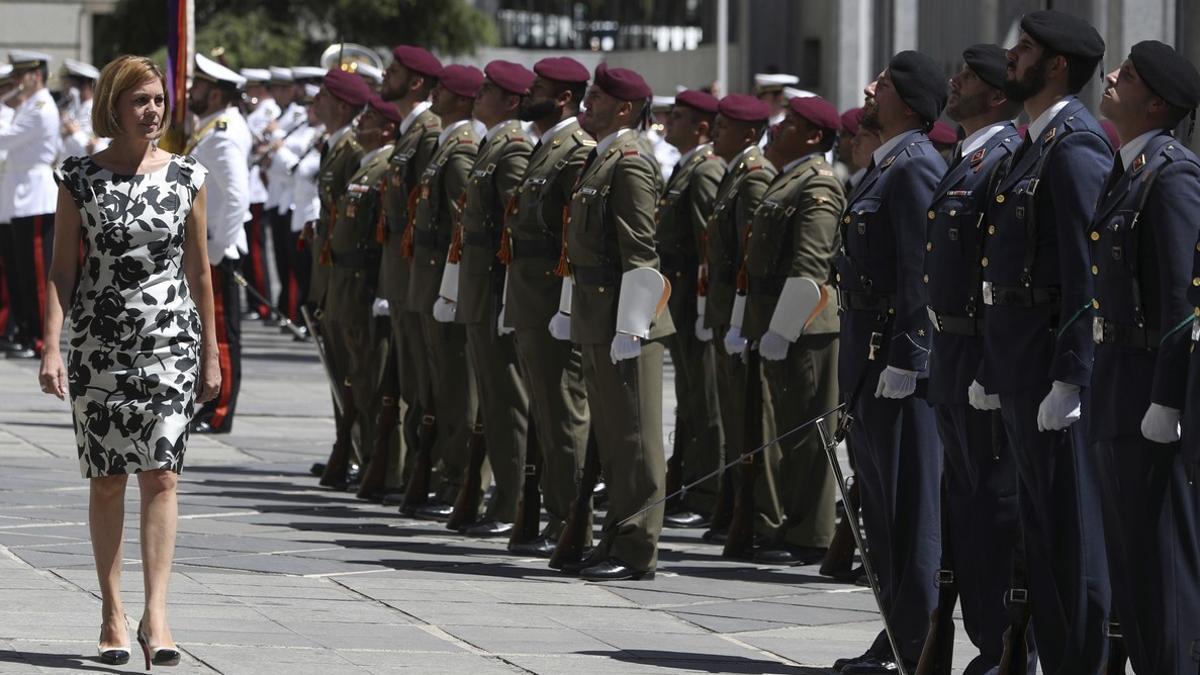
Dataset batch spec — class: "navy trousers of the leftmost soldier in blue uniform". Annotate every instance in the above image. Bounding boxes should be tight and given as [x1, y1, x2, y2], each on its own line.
[851, 362, 942, 662]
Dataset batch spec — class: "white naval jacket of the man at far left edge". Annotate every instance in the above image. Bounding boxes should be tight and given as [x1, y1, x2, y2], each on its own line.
[0, 88, 60, 222]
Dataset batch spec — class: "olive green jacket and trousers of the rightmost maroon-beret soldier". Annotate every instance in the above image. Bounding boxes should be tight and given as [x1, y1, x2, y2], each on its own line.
[742, 154, 846, 548]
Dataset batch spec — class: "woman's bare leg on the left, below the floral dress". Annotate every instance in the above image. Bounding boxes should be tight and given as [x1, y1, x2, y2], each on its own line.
[88, 474, 130, 647]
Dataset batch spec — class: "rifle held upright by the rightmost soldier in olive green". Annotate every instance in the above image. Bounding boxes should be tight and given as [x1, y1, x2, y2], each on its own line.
[721, 350, 762, 558]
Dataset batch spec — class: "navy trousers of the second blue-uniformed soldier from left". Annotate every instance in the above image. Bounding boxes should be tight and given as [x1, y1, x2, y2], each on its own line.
[934, 404, 1019, 675]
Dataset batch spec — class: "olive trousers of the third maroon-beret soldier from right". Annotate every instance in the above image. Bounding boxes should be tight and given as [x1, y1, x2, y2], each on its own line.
[666, 329, 722, 514]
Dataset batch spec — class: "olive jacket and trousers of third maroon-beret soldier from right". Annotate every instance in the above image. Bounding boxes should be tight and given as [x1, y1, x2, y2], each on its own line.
[656, 144, 725, 514]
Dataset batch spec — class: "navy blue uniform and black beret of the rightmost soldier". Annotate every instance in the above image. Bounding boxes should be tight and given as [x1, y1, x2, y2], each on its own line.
[1088, 41, 1200, 675]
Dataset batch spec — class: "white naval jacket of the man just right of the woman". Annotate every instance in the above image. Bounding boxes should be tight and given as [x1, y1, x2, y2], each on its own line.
[188, 106, 253, 265]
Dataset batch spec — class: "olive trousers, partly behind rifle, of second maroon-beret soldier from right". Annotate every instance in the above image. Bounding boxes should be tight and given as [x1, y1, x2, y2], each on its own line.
[713, 328, 784, 537]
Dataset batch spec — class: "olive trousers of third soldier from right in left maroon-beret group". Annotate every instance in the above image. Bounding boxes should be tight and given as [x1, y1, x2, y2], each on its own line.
[466, 322, 529, 522]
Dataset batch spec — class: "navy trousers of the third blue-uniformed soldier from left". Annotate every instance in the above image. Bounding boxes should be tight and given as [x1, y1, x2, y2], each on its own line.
[1000, 382, 1109, 675]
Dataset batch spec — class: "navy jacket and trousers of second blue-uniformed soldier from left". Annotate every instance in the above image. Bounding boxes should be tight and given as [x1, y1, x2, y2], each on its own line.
[924, 118, 1020, 673]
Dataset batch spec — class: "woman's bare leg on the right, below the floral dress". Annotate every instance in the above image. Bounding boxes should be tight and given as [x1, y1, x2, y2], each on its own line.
[138, 468, 179, 647]
